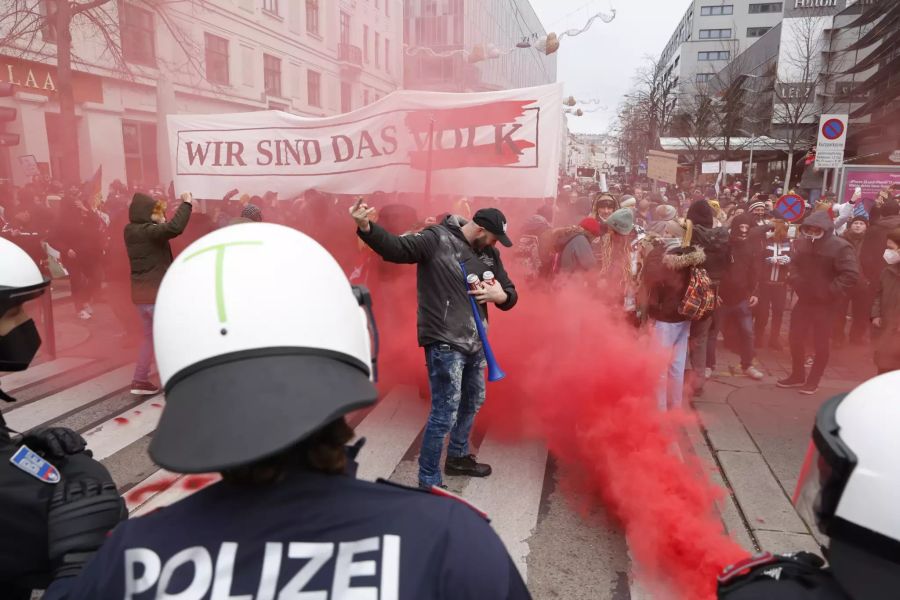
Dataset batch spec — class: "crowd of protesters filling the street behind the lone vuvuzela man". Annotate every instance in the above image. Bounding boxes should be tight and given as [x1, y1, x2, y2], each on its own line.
[0, 172, 900, 409]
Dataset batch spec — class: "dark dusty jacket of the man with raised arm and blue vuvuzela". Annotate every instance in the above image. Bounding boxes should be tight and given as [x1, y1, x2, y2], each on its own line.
[357, 216, 518, 354]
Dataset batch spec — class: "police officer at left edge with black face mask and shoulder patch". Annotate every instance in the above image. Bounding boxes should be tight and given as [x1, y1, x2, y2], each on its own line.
[0, 238, 125, 600]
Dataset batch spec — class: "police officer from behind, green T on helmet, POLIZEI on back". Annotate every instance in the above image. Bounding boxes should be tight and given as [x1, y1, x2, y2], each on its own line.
[45, 223, 530, 600]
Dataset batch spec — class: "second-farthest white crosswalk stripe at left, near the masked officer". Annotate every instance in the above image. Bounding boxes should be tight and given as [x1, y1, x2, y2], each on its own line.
[4, 365, 134, 431]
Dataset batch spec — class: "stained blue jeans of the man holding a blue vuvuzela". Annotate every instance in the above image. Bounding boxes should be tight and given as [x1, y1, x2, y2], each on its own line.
[419, 344, 487, 486]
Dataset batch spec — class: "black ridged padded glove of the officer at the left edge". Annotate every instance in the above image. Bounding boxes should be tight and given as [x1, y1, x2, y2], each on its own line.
[47, 478, 128, 578]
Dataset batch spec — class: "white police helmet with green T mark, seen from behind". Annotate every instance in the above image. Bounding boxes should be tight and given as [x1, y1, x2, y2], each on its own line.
[150, 223, 377, 473]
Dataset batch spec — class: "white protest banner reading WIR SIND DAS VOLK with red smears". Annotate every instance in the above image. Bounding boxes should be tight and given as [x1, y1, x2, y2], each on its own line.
[168, 84, 562, 198]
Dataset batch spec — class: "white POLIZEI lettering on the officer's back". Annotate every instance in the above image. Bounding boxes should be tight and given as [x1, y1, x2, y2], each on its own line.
[124, 535, 400, 600]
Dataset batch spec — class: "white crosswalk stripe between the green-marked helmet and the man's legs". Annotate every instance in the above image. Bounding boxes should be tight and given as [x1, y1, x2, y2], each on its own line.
[356, 386, 428, 481]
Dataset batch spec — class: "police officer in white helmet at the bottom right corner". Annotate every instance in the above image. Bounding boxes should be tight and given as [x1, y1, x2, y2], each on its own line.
[719, 371, 900, 600]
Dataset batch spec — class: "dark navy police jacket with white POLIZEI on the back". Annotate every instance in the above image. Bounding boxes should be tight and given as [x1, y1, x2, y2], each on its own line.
[44, 470, 530, 600]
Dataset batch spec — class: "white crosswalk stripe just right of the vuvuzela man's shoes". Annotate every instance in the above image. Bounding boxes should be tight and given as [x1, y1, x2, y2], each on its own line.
[463, 433, 547, 579]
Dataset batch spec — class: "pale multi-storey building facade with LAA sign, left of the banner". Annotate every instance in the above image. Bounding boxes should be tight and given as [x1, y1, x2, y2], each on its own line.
[0, 0, 403, 185]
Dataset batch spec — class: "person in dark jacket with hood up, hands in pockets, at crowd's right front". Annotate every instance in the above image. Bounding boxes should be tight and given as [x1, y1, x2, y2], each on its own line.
[776, 210, 860, 394]
